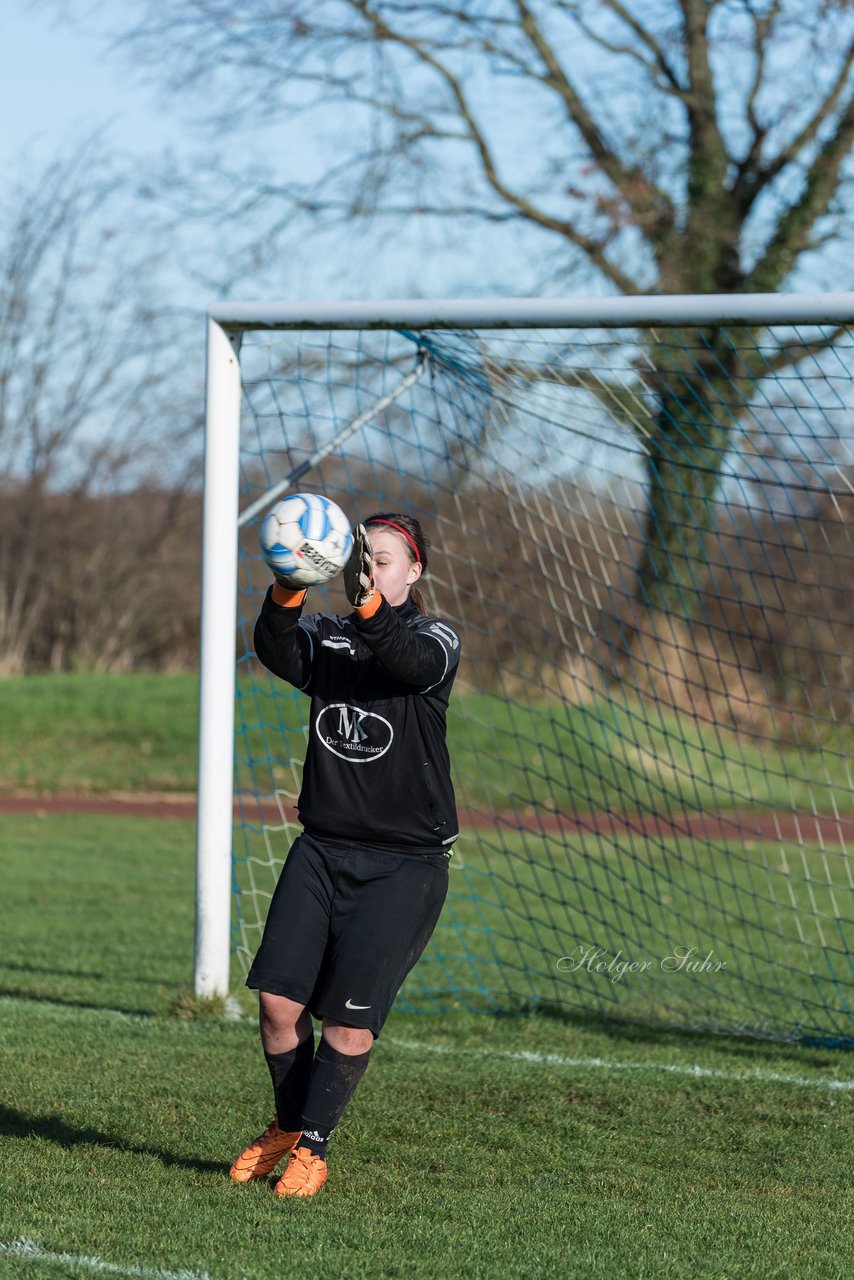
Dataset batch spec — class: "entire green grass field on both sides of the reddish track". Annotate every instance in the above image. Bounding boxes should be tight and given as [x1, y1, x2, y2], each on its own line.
[0, 675, 854, 1280]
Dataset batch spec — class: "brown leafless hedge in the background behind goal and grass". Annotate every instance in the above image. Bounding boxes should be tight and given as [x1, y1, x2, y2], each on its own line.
[0, 453, 854, 745]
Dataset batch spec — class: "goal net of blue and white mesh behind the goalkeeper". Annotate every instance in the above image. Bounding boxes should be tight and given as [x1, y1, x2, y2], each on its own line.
[197, 296, 854, 1046]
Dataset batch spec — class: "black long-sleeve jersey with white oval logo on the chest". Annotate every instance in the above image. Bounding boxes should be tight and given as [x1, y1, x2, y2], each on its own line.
[255, 591, 460, 852]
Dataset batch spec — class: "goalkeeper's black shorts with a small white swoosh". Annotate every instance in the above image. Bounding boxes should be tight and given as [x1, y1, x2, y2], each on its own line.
[246, 832, 449, 1037]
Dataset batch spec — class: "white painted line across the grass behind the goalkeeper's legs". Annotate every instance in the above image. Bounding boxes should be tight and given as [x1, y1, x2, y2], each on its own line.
[0, 996, 854, 1093]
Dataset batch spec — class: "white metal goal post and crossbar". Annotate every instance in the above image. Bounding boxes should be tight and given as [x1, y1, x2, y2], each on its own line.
[193, 293, 854, 1029]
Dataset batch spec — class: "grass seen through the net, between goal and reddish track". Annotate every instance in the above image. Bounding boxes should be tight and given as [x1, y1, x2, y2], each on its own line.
[236, 826, 854, 1047]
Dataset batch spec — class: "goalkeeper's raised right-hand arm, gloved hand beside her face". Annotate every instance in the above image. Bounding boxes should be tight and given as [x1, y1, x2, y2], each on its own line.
[344, 525, 460, 691]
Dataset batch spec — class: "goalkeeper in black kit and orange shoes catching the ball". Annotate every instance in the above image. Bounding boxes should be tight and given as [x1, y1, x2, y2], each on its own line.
[230, 512, 460, 1196]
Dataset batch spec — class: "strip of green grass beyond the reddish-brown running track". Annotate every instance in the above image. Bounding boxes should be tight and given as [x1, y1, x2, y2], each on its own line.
[0, 673, 854, 813]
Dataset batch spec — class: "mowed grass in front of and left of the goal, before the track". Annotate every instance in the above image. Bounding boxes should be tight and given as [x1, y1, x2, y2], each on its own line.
[0, 817, 854, 1280]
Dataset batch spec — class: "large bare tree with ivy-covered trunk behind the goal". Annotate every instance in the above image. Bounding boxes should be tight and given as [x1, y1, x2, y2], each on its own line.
[83, 0, 854, 627]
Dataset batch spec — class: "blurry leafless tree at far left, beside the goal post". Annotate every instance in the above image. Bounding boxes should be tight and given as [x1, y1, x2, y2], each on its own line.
[0, 138, 202, 672]
